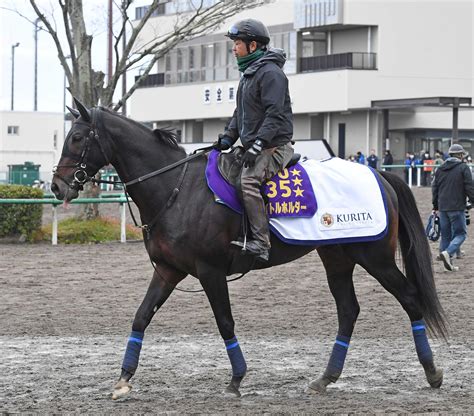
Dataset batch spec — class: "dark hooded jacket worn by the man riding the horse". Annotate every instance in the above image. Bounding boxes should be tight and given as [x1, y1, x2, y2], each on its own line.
[225, 48, 293, 149]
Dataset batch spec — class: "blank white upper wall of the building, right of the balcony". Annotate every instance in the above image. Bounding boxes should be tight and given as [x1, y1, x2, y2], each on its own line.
[344, 0, 474, 82]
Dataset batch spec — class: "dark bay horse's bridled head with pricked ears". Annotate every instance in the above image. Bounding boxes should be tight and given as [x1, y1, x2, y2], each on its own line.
[51, 98, 110, 202]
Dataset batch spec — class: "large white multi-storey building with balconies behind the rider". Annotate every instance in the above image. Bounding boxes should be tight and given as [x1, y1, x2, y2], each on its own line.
[130, 0, 474, 161]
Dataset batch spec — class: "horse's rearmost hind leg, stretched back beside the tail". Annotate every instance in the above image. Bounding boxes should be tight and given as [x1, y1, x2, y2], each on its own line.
[346, 246, 443, 388]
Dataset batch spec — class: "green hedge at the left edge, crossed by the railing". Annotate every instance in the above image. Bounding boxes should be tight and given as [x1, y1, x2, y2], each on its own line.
[0, 185, 43, 241]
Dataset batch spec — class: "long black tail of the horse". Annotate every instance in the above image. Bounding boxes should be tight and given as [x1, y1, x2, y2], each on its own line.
[380, 172, 448, 339]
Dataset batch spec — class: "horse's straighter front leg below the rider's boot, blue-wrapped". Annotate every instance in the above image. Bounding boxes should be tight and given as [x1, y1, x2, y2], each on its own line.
[199, 265, 247, 397]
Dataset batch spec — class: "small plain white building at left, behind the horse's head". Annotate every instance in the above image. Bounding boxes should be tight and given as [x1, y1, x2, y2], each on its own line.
[0, 111, 64, 183]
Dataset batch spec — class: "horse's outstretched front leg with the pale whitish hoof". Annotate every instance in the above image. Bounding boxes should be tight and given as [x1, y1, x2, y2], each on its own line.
[112, 265, 186, 400]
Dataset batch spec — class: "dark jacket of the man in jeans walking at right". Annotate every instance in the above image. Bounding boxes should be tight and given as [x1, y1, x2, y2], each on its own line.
[431, 157, 474, 211]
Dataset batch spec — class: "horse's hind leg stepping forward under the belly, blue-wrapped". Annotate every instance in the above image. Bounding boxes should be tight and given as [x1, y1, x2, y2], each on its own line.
[308, 246, 360, 392]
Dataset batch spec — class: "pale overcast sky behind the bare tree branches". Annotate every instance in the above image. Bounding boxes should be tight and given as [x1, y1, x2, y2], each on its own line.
[0, 0, 151, 112]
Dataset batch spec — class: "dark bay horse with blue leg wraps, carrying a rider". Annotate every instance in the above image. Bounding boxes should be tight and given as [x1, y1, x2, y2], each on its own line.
[51, 100, 447, 398]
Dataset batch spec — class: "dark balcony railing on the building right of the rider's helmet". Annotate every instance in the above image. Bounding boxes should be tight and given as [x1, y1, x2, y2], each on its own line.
[300, 52, 377, 72]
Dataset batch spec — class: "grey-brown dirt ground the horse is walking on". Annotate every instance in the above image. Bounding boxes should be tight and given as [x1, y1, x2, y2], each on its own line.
[0, 189, 474, 414]
